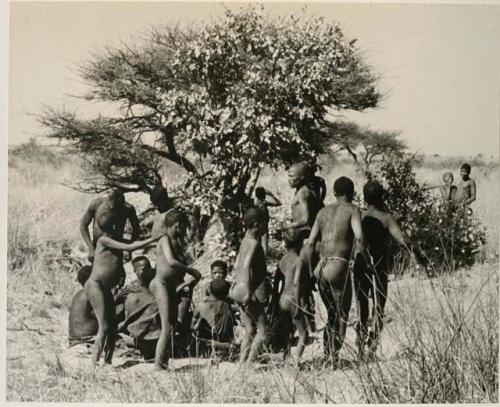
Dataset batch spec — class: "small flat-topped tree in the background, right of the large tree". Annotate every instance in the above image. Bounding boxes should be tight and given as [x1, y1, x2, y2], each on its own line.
[324, 122, 407, 170]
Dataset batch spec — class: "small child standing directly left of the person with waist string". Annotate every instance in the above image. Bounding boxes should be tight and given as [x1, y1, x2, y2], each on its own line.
[273, 231, 311, 361]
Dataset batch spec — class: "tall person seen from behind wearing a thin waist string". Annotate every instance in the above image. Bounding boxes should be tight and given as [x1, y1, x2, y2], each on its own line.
[308, 177, 365, 366]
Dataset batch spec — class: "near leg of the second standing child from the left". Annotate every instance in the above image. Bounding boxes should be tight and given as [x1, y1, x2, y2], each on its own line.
[149, 280, 173, 370]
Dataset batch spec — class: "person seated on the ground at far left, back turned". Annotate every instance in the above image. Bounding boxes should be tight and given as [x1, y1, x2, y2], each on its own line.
[68, 265, 98, 346]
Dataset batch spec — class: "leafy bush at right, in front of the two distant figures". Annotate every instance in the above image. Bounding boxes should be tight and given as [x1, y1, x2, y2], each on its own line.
[366, 157, 486, 270]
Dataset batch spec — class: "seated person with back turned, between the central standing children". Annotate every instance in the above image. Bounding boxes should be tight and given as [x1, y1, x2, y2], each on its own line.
[192, 277, 235, 356]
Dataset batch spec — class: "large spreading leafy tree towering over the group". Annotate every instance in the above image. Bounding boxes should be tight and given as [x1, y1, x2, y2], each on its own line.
[40, 7, 379, 242]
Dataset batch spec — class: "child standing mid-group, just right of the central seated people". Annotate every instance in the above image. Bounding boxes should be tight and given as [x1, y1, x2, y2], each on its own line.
[229, 207, 269, 363]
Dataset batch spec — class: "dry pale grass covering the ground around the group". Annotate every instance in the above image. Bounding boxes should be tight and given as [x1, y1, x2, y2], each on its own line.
[7, 148, 499, 403]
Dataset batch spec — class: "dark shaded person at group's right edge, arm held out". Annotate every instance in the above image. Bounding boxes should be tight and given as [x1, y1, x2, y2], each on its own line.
[354, 181, 414, 359]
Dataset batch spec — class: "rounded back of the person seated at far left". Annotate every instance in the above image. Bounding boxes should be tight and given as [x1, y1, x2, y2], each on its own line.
[68, 289, 98, 338]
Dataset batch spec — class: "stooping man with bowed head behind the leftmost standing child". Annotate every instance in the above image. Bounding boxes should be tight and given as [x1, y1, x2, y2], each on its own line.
[80, 189, 140, 261]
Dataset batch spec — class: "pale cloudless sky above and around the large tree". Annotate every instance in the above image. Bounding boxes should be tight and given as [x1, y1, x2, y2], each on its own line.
[8, 2, 500, 156]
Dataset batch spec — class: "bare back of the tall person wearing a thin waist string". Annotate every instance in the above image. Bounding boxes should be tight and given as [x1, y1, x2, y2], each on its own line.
[318, 202, 356, 259]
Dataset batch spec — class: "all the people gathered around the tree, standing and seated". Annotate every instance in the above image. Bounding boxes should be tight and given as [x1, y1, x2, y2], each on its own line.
[69, 163, 475, 370]
